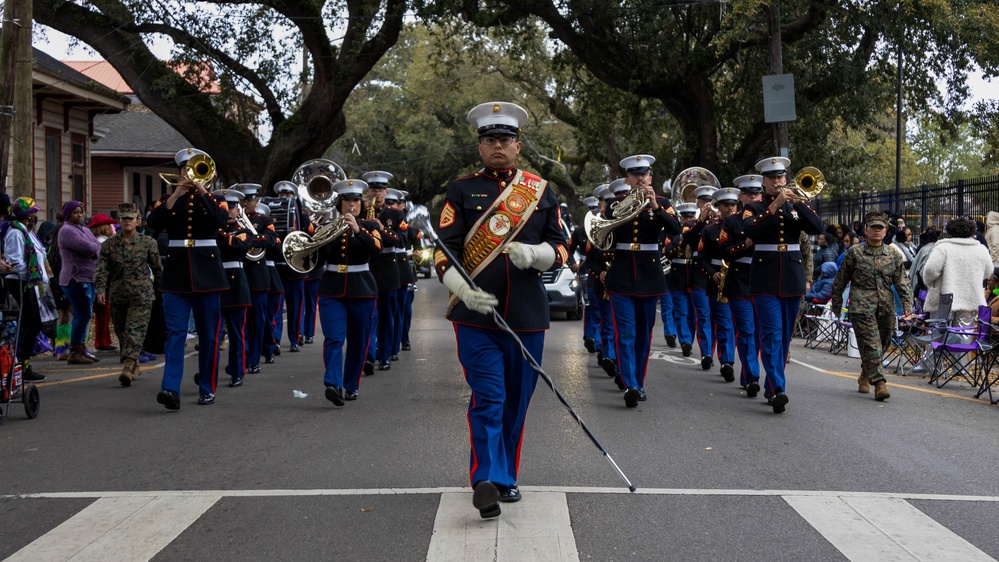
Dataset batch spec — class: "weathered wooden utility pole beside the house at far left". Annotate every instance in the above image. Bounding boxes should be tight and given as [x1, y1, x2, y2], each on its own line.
[5, 0, 34, 199]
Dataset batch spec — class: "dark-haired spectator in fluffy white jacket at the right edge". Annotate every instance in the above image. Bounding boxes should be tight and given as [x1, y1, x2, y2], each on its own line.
[922, 218, 993, 325]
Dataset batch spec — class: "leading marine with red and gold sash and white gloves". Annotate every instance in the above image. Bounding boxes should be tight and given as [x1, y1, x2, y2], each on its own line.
[434, 102, 568, 518]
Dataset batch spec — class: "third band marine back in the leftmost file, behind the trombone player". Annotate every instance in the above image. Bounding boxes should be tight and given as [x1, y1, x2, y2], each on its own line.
[239, 183, 277, 374]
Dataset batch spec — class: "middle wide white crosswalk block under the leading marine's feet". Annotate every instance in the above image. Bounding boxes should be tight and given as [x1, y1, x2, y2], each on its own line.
[427, 491, 579, 562]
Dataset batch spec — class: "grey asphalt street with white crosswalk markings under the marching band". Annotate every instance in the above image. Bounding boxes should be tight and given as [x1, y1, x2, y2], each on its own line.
[0, 280, 999, 560]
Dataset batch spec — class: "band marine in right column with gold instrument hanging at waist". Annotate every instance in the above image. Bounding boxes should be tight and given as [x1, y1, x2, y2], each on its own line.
[697, 187, 739, 382]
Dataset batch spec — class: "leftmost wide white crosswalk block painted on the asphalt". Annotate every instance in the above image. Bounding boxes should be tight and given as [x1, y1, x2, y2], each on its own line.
[7, 492, 219, 562]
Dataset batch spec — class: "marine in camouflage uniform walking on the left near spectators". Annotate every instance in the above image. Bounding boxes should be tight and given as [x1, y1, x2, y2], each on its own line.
[96, 203, 163, 386]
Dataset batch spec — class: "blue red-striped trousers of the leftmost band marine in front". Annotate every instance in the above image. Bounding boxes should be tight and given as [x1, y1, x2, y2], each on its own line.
[162, 292, 222, 394]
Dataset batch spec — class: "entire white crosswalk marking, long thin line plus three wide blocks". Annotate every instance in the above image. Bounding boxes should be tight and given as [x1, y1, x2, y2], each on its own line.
[2, 486, 999, 562]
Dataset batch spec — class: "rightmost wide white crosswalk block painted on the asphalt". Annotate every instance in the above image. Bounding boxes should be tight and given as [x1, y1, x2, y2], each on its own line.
[784, 496, 995, 562]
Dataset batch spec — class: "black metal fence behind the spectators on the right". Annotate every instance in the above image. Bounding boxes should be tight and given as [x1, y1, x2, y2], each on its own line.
[812, 172, 999, 231]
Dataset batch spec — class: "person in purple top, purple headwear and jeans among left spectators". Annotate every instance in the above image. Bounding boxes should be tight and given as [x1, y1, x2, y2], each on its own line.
[59, 201, 101, 365]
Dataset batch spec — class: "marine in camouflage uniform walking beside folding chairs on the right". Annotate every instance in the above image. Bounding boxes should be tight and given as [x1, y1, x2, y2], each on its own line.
[832, 213, 912, 400]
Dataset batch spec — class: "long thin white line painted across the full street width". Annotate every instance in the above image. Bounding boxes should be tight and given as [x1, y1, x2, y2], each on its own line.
[11, 486, 999, 502]
